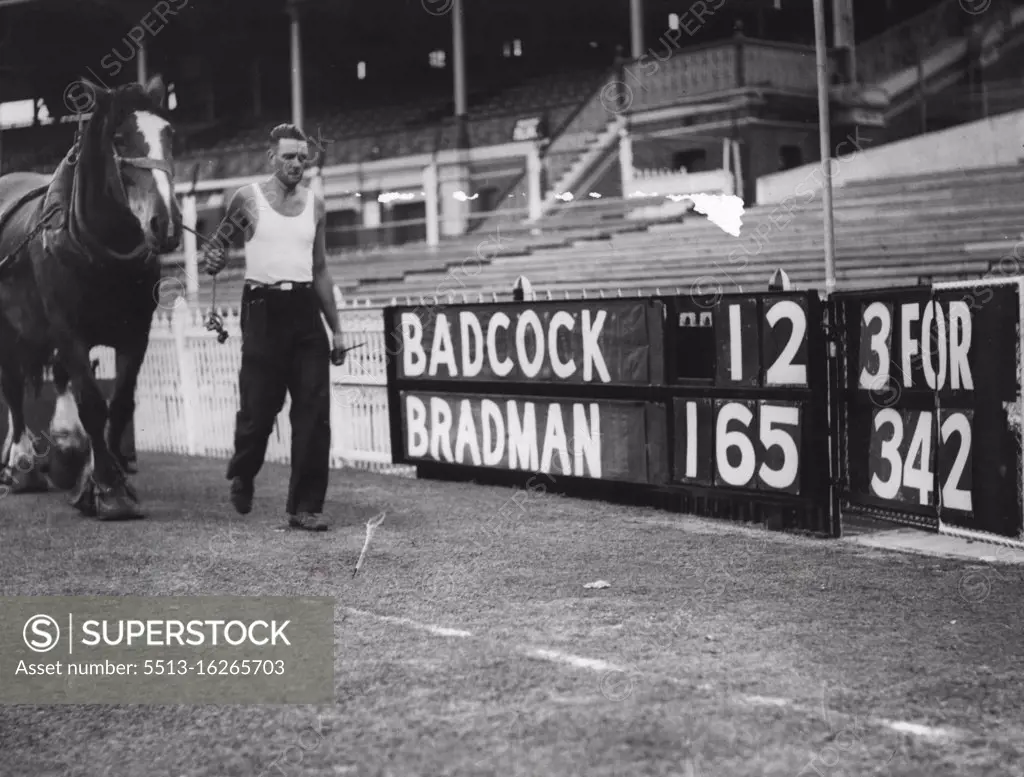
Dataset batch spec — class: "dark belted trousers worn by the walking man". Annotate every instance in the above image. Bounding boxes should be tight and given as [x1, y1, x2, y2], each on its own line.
[227, 287, 331, 515]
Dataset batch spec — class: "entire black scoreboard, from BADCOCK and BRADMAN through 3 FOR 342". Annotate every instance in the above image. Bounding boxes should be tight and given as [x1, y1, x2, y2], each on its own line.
[385, 283, 1024, 539]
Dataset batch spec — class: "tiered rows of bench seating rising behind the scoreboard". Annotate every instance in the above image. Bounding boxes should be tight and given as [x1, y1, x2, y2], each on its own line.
[174, 163, 1024, 305]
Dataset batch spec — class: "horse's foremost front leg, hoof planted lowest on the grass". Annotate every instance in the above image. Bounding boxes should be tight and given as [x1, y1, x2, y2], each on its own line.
[59, 343, 140, 519]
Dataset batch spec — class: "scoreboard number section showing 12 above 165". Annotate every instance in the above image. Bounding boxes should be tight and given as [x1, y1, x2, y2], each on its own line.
[666, 292, 828, 504]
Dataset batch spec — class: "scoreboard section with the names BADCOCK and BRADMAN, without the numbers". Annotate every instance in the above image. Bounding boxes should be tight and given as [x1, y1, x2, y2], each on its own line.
[385, 299, 668, 484]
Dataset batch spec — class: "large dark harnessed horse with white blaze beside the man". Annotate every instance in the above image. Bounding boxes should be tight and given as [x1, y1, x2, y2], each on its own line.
[0, 76, 182, 520]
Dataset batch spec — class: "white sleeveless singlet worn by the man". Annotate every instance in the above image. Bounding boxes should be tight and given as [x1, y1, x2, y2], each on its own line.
[246, 183, 316, 284]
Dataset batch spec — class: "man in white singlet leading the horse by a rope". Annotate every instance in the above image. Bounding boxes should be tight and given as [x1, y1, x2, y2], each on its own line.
[205, 124, 344, 531]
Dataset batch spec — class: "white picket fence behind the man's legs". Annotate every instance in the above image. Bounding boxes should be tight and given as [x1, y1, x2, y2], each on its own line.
[92, 300, 415, 475]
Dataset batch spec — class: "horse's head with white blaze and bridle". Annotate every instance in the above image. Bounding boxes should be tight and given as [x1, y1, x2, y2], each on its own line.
[77, 76, 181, 253]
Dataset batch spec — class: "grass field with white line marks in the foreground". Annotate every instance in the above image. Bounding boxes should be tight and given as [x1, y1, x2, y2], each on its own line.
[0, 454, 1024, 777]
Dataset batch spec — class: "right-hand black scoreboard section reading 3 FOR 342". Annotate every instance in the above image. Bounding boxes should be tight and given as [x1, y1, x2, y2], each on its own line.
[834, 284, 1021, 538]
